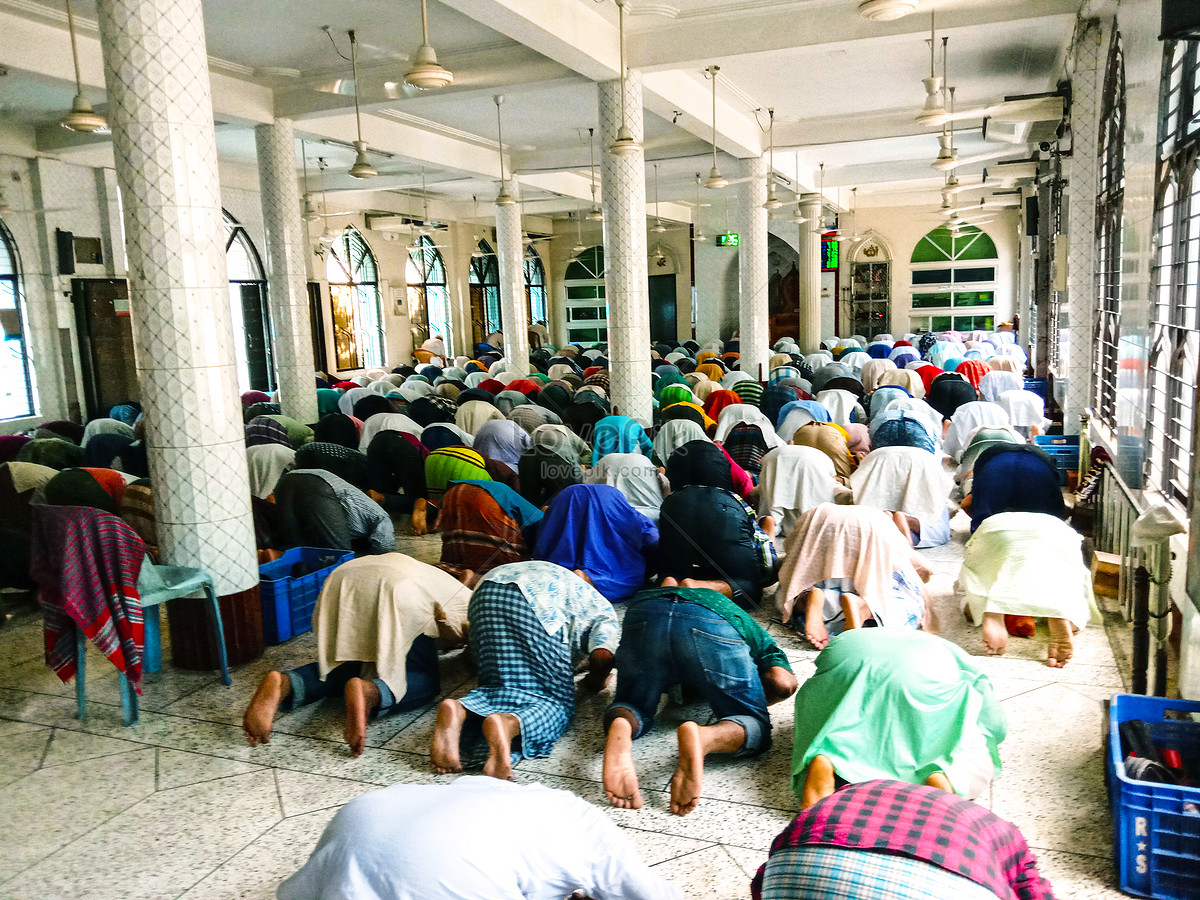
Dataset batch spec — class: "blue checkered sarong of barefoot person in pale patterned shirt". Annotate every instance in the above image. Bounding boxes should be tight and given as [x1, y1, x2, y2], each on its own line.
[461, 581, 575, 766]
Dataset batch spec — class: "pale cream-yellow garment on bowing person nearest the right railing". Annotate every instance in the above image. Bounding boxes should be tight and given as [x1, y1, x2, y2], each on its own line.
[955, 512, 1099, 628]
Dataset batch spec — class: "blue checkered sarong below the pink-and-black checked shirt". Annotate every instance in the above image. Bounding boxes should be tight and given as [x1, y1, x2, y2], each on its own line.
[762, 845, 996, 900]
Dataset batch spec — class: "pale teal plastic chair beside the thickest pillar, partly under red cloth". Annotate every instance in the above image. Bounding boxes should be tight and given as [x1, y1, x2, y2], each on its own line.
[74, 557, 233, 726]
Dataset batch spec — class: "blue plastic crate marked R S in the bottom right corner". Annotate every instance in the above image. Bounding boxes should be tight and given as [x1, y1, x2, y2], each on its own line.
[1104, 694, 1200, 900]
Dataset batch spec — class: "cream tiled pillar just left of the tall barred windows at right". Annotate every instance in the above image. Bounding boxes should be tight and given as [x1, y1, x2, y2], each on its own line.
[1062, 19, 1104, 434]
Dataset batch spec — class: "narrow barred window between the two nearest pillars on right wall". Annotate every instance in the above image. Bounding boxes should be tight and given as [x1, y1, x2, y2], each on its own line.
[1092, 32, 1126, 428]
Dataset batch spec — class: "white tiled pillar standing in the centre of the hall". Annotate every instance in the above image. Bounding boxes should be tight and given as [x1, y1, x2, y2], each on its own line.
[598, 71, 654, 420]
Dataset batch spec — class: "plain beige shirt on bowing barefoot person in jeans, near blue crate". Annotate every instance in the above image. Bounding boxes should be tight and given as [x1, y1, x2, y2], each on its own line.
[312, 553, 470, 700]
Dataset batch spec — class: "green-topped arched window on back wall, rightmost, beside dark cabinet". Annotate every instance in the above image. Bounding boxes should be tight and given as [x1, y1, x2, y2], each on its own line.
[908, 226, 1000, 331]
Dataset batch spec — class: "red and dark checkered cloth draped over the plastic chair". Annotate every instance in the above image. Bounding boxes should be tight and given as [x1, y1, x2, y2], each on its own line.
[30, 505, 145, 694]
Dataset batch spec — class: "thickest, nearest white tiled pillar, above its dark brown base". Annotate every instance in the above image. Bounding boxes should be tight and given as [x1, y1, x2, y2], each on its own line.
[96, 0, 258, 595]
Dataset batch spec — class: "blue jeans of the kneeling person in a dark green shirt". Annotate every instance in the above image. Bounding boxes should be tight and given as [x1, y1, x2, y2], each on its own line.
[605, 595, 770, 756]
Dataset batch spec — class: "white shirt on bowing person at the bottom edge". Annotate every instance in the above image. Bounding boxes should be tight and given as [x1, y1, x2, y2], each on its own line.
[276, 775, 680, 900]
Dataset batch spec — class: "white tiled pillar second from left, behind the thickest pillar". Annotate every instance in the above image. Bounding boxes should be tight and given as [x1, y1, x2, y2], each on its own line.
[254, 119, 317, 422]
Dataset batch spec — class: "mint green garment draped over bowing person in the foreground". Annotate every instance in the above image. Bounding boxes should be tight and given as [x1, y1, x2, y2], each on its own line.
[792, 628, 1008, 797]
